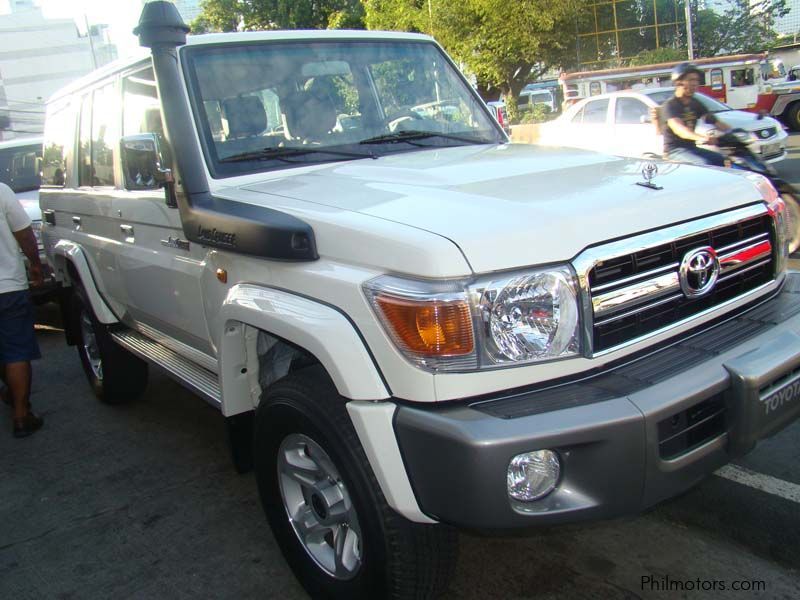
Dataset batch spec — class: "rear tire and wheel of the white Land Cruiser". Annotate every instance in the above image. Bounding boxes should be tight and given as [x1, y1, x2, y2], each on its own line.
[71, 286, 147, 404]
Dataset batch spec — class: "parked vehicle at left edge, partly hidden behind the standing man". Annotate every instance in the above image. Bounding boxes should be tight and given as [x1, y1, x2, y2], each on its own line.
[0, 137, 56, 300]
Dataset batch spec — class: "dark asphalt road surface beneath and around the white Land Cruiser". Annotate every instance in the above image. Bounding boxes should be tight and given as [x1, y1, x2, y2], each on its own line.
[0, 136, 800, 600]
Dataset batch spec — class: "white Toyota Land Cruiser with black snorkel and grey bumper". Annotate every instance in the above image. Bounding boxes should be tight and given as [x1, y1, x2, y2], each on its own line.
[41, 2, 800, 598]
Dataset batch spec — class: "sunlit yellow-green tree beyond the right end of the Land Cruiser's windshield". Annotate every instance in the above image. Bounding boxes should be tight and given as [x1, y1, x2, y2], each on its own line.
[364, 0, 583, 120]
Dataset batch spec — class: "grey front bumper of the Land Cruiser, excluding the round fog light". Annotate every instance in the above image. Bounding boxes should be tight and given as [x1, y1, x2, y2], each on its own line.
[394, 273, 800, 530]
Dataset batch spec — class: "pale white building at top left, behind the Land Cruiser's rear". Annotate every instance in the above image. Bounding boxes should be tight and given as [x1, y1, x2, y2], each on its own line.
[0, 0, 116, 139]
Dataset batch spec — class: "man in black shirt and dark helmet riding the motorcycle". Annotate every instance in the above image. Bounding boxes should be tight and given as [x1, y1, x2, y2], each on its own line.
[661, 62, 730, 167]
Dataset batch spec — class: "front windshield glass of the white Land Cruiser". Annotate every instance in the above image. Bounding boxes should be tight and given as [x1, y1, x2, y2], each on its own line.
[187, 41, 505, 176]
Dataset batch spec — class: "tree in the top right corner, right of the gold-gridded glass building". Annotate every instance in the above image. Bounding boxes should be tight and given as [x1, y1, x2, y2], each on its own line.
[693, 0, 789, 56]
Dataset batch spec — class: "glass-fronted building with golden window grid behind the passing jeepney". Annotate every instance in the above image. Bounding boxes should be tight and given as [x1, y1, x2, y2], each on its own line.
[576, 0, 686, 70]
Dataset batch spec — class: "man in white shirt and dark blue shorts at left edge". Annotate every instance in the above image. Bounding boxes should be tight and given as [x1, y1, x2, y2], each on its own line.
[0, 183, 44, 437]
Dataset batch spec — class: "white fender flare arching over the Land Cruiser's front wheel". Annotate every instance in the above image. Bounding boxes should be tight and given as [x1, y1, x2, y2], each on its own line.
[218, 283, 391, 416]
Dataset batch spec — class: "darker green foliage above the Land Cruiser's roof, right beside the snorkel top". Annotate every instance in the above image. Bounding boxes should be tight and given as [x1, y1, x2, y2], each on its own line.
[192, 0, 364, 33]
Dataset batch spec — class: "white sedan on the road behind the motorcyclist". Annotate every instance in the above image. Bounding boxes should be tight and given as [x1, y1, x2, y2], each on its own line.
[540, 88, 788, 163]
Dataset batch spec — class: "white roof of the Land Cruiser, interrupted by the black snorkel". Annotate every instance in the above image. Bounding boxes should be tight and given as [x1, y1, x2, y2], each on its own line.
[47, 29, 434, 103]
